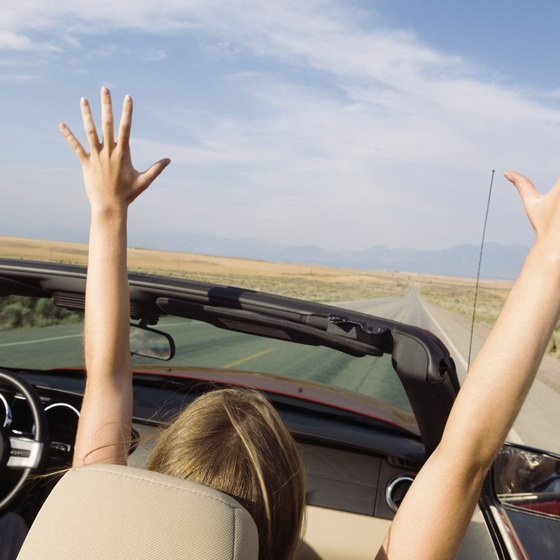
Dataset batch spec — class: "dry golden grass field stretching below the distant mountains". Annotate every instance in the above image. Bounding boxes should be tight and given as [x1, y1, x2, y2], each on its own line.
[0, 237, 560, 357]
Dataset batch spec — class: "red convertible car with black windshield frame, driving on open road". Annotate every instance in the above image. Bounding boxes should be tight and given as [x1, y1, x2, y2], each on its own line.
[0, 259, 560, 560]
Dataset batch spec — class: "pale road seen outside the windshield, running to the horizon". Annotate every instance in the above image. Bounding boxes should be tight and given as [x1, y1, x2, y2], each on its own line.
[337, 285, 560, 453]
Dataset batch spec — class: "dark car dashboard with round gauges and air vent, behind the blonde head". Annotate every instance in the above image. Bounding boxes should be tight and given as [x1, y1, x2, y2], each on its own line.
[0, 370, 423, 519]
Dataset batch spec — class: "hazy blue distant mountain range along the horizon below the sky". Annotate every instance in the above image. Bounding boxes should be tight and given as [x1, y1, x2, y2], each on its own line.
[0, 227, 528, 280]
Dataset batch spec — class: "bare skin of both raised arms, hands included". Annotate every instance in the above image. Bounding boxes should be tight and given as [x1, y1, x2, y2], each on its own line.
[60, 88, 560, 560]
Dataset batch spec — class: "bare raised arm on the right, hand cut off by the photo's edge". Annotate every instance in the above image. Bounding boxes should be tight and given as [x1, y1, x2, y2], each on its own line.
[377, 172, 560, 560]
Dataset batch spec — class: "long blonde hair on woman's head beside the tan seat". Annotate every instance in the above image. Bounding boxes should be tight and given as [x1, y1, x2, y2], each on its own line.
[142, 388, 305, 560]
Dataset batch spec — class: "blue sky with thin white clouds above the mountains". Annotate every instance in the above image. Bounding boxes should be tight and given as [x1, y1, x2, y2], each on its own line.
[0, 0, 560, 251]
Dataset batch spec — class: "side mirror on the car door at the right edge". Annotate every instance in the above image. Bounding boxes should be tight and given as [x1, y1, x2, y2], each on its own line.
[494, 444, 560, 518]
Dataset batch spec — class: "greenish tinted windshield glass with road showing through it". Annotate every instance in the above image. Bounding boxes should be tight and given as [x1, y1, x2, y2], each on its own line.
[0, 296, 412, 414]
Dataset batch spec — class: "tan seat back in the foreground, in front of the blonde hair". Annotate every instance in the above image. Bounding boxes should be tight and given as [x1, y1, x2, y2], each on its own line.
[18, 465, 258, 560]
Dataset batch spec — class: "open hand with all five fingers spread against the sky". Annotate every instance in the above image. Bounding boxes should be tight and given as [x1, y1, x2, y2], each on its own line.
[60, 87, 170, 210]
